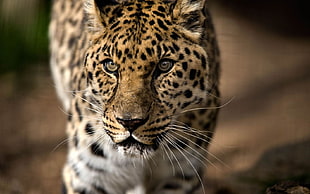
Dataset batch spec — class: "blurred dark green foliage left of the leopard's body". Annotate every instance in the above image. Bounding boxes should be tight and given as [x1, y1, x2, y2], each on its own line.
[0, 1, 50, 75]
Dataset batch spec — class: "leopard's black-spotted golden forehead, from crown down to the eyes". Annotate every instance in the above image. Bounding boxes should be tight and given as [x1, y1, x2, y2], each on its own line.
[92, 1, 191, 74]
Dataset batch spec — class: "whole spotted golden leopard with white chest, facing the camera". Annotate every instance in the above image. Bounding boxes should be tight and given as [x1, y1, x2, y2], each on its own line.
[49, 0, 220, 194]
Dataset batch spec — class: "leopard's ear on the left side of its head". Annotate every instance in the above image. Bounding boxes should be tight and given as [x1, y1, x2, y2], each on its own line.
[84, 0, 125, 33]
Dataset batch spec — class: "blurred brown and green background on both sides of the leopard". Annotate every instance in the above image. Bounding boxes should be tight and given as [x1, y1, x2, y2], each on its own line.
[0, 0, 310, 194]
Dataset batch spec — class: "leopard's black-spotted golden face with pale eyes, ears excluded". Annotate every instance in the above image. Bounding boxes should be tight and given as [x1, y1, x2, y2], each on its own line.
[85, 2, 209, 156]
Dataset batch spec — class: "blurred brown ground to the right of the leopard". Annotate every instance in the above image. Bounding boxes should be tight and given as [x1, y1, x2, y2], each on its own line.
[207, 0, 310, 194]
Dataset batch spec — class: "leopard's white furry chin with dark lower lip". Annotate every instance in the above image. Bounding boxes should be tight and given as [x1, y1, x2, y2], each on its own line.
[116, 136, 159, 159]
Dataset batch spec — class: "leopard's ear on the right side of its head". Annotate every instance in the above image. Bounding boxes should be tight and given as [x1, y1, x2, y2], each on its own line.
[168, 0, 206, 41]
